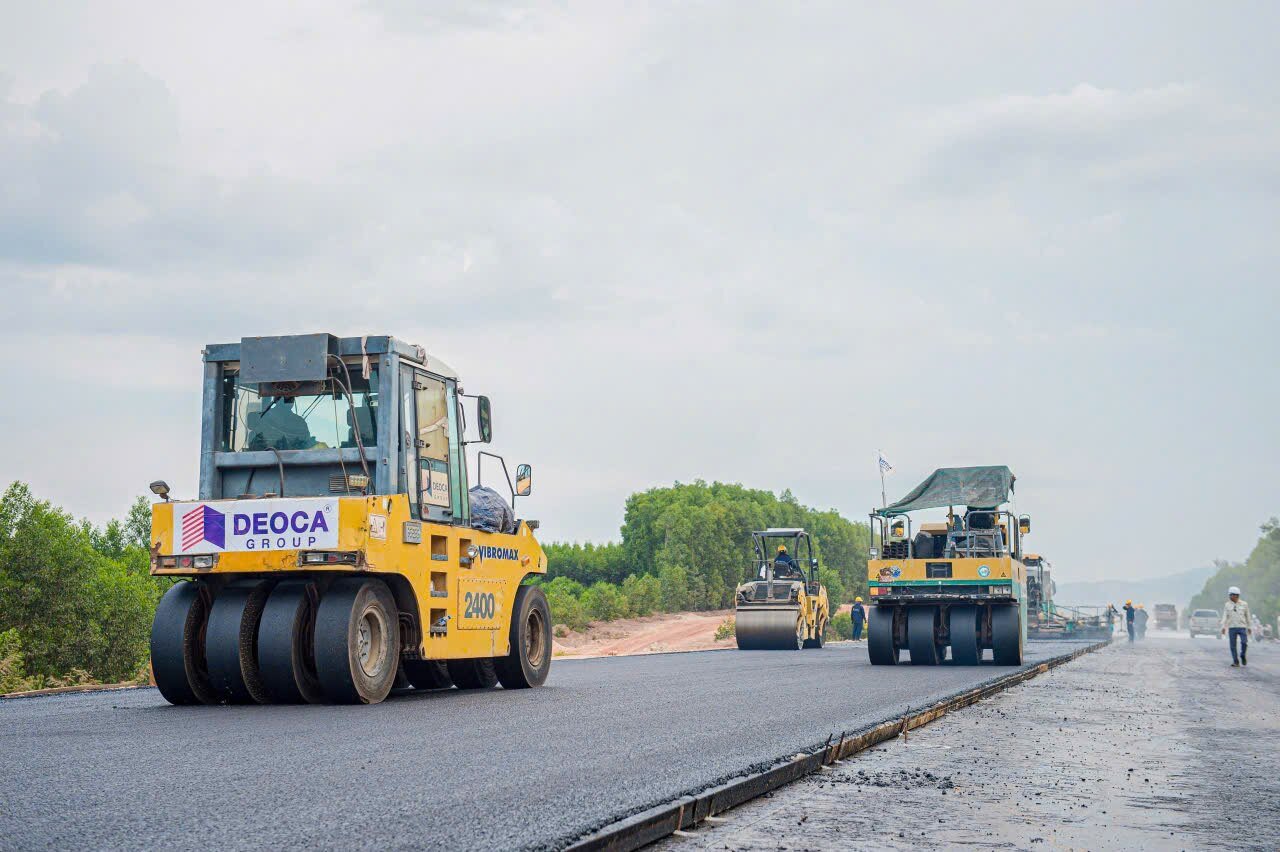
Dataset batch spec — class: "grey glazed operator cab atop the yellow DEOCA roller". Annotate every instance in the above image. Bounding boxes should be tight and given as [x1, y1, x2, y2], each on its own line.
[200, 334, 530, 525]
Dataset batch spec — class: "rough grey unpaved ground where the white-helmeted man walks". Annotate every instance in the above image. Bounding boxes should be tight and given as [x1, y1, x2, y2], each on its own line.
[659, 633, 1280, 852]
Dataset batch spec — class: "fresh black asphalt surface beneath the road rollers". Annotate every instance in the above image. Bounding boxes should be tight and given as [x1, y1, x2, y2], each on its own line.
[0, 642, 1079, 849]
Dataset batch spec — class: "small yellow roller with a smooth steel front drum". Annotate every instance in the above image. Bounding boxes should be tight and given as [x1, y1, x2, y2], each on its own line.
[733, 528, 831, 650]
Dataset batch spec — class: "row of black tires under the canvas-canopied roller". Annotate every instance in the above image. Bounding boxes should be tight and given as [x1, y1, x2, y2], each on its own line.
[867, 605, 1023, 665]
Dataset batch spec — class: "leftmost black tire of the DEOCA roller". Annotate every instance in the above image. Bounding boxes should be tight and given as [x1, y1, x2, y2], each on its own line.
[151, 582, 218, 705]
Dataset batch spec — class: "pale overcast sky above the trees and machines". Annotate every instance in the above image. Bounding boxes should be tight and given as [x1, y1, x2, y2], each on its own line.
[0, 0, 1280, 582]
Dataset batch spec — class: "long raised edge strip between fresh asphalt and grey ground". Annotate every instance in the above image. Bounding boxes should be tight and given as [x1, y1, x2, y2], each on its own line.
[567, 640, 1111, 852]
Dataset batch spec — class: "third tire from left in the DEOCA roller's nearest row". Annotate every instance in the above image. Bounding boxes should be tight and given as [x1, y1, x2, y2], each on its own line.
[257, 580, 325, 704]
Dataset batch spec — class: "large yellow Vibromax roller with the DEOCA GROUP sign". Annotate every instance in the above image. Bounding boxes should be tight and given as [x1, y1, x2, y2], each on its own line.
[151, 334, 552, 705]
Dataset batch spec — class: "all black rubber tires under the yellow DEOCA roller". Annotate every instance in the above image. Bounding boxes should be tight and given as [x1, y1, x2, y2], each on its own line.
[151, 577, 552, 705]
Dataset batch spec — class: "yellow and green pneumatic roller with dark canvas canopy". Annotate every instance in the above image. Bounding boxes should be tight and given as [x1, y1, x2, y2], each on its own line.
[867, 466, 1030, 665]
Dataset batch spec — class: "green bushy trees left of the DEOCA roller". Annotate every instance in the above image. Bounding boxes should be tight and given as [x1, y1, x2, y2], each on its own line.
[0, 482, 169, 692]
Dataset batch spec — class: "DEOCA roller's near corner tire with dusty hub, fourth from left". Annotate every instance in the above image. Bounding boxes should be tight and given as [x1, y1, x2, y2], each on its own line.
[312, 577, 399, 704]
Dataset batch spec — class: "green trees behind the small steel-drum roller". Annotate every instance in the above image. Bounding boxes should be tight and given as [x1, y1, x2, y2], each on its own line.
[544, 481, 870, 629]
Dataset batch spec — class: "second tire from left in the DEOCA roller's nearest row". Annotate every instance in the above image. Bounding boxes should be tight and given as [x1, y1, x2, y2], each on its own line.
[205, 580, 271, 704]
